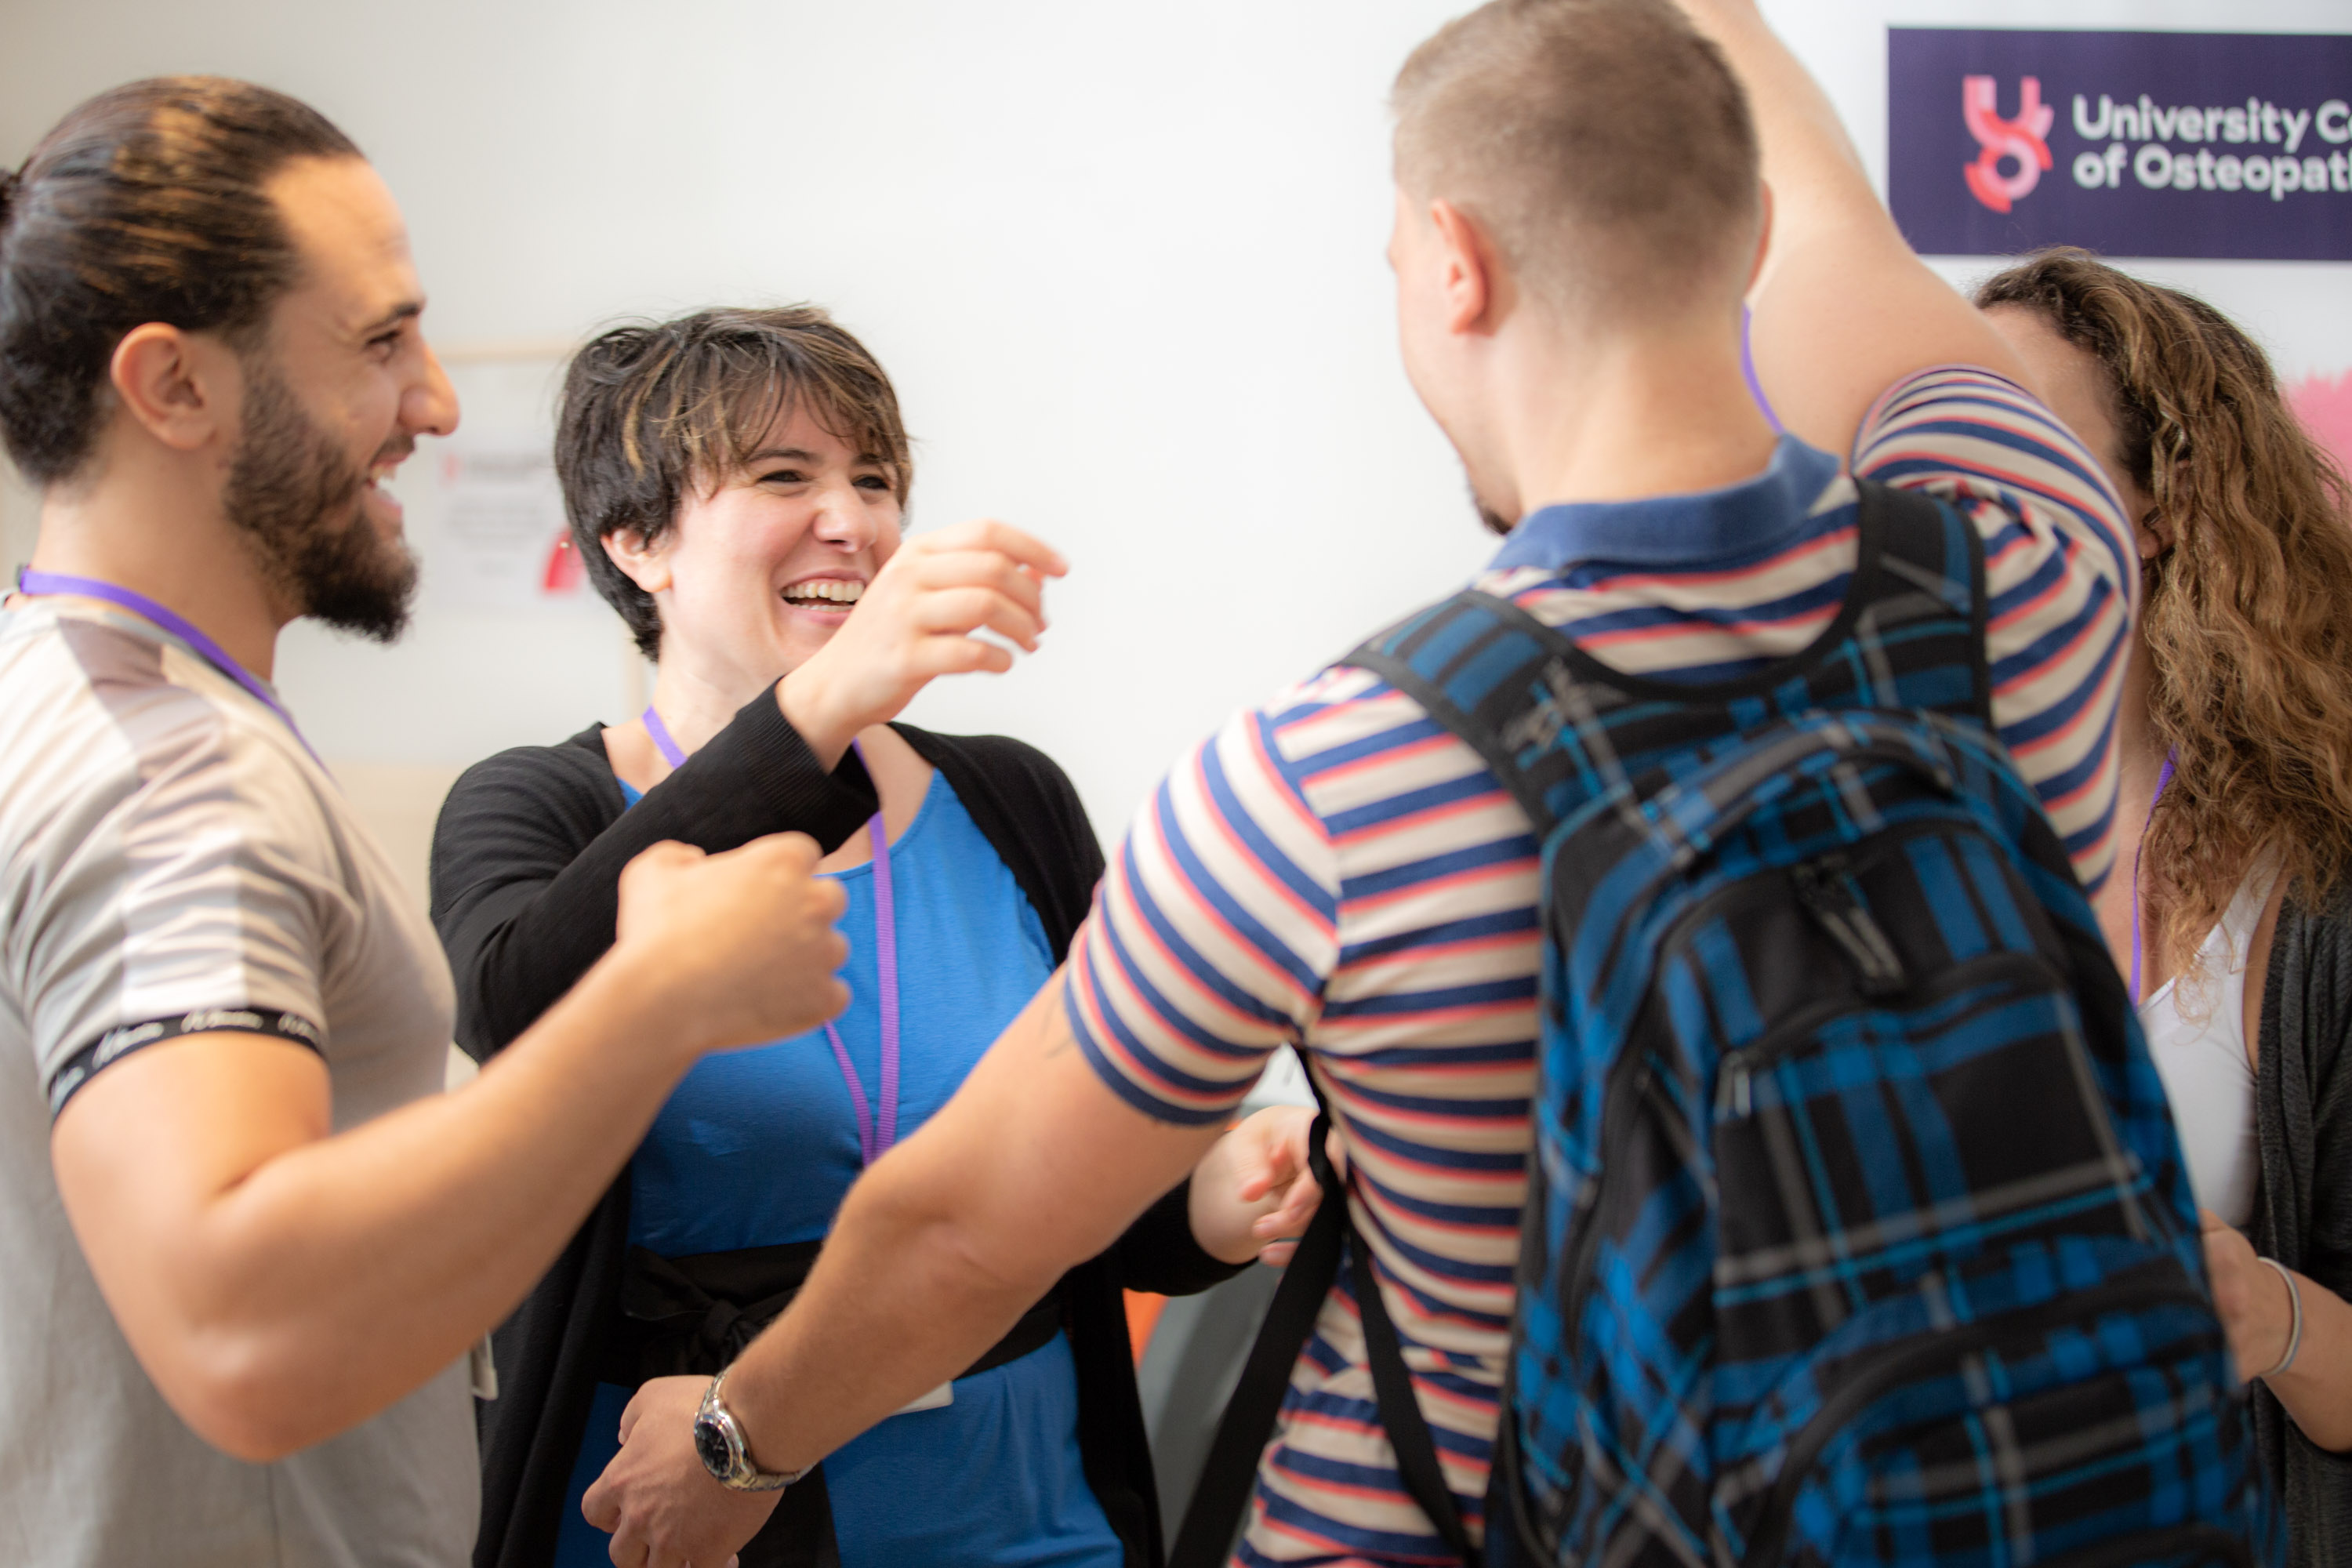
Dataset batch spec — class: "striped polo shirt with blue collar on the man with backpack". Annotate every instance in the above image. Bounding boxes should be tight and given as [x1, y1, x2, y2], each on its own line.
[1065, 367, 2136, 1563]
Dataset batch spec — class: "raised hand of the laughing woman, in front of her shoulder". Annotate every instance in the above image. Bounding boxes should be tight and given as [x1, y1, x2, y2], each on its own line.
[776, 522, 1068, 769]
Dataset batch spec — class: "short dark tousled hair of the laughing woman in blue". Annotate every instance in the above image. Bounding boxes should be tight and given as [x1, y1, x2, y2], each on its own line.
[555, 306, 915, 659]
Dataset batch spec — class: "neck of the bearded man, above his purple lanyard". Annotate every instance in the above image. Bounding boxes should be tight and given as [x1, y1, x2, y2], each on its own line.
[31, 446, 294, 680]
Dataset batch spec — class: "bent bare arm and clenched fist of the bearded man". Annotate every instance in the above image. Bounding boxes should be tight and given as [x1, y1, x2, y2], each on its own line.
[49, 837, 847, 1460]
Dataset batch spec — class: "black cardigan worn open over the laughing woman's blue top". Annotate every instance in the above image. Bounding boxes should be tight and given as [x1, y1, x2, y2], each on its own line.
[433, 694, 1237, 1568]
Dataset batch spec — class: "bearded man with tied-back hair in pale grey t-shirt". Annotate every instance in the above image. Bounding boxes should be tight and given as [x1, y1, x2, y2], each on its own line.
[0, 78, 847, 1568]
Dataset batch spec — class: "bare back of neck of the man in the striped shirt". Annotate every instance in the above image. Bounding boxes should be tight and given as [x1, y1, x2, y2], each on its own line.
[1501, 314, 1776, 515]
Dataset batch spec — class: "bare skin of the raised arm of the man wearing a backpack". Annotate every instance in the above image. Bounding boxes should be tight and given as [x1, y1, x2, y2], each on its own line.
[1682, 0, 2025, 454]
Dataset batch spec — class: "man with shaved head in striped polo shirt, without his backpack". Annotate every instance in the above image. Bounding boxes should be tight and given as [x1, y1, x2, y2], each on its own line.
[588, 0, 2136, 1568]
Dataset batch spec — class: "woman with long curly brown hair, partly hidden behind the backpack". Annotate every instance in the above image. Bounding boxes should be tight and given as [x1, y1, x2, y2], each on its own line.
[1976, 249, 2352, 1568]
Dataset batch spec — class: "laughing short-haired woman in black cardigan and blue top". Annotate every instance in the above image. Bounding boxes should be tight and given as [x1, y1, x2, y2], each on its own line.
[433, 308, 1305, 1568]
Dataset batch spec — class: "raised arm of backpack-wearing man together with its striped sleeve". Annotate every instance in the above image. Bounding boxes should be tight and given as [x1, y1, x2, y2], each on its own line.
[1682, 0, 2138, 891]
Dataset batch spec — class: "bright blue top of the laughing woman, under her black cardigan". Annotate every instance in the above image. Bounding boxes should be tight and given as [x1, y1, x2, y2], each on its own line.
[555, 774, 1122, 1568]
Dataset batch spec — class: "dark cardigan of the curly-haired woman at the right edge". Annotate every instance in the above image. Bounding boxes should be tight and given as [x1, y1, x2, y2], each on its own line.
[2251, 888, 2352, 1568]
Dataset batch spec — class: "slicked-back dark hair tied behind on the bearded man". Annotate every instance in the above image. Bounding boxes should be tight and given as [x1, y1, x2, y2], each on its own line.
[0, 75, 360, 485]
